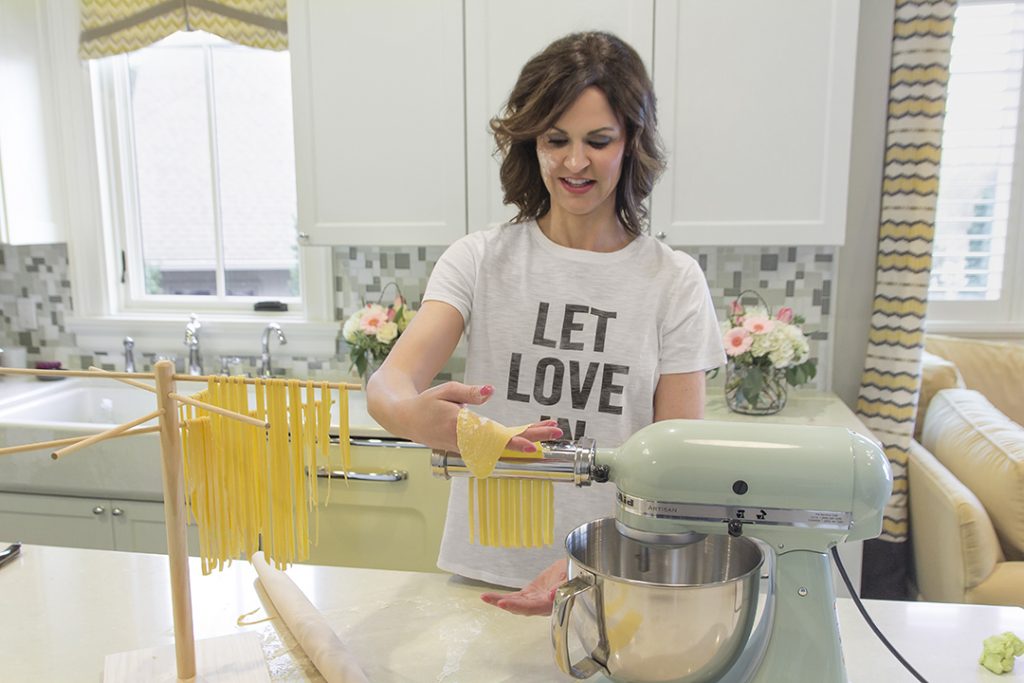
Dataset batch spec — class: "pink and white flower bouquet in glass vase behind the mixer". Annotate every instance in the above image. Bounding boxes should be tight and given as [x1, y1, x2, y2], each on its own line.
[722, 293, 817, 413]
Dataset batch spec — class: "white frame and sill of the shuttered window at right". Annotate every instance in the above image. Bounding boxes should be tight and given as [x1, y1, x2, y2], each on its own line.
[926, 0, 1024, 337]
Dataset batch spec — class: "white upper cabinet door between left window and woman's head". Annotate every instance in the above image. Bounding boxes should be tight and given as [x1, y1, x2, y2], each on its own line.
[288, 0, 466, 245]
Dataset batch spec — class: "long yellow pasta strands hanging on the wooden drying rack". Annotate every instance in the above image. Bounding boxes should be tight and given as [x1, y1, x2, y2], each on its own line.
[180, 377, 348, 573]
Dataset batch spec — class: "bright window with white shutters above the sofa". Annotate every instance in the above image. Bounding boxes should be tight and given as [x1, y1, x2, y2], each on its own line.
[928, 0, 1024, 332]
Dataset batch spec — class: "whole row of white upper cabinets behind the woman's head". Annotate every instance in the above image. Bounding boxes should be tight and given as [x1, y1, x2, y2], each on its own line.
[289, 0, 859, 245]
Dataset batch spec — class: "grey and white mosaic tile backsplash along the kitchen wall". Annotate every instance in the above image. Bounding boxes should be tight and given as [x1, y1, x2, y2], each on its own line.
[0, 240, 838, 388]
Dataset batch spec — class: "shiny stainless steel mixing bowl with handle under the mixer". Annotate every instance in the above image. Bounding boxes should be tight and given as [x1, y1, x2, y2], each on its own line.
[551, 518, 764, 683]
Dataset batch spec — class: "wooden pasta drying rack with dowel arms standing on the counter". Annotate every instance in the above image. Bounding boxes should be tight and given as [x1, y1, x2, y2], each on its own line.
[0, 360, 361, 683]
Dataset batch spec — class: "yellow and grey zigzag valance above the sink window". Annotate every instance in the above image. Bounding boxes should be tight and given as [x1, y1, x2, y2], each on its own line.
[79, 0, 288, 59]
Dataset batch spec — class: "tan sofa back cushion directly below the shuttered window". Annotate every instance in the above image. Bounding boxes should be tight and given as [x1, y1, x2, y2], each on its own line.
[925, 335, 1024, 424]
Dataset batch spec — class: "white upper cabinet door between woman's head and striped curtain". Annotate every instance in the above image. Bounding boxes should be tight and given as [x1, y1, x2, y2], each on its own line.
[651, 0, 858, 245]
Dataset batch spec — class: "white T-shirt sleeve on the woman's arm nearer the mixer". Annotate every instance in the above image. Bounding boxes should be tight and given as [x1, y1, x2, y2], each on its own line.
[658, 252, 725, 375]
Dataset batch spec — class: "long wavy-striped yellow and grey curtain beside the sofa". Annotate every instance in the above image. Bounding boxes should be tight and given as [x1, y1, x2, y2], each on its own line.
[857, 0, 956, 543]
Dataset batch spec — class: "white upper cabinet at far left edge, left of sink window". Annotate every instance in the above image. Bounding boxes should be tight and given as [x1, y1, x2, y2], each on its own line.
[0, 0, 67, 245]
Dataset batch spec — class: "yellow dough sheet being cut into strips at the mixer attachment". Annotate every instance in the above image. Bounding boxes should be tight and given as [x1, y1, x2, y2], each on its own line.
[457, 408, 555, 548]
